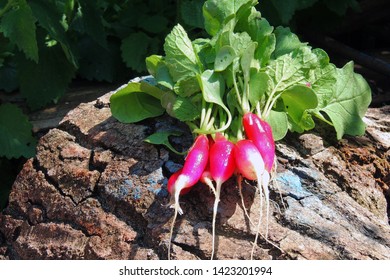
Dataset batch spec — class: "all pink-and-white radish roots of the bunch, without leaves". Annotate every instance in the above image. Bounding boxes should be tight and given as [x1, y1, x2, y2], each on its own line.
[168, 112, 275, 259]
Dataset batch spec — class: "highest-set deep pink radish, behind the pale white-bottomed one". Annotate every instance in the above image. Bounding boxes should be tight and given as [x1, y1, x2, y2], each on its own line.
[242, 113, 275, 172]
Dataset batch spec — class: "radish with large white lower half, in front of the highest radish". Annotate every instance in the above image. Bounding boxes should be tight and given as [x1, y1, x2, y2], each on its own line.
[234, 140, 270, 259]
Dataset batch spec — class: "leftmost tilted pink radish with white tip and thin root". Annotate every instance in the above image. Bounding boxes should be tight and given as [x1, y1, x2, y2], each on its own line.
[168, 134, 209, 259]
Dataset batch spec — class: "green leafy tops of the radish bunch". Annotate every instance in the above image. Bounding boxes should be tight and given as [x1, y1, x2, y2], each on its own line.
[111, 0, 371, 148]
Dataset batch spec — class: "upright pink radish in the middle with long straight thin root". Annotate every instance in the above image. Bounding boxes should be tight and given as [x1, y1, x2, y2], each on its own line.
[210, 134, 236, 259]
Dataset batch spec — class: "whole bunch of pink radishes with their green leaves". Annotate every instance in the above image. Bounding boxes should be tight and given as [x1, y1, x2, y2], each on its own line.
[110, 0, 371, 258]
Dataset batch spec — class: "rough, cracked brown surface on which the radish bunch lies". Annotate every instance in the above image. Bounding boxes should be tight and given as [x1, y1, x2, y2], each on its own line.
[0, 86, 390, 259]
